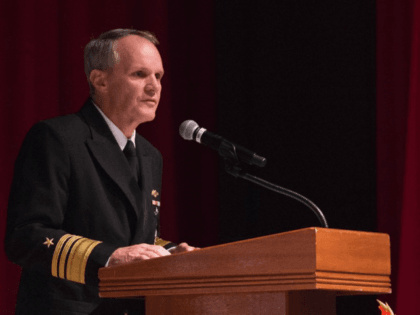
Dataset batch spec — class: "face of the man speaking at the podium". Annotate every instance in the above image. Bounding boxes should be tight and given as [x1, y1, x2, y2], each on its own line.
[104, 35, 164, 125]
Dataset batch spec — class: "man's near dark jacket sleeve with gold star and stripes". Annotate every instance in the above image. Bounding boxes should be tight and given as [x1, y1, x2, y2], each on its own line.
[5, 122, 117, 284]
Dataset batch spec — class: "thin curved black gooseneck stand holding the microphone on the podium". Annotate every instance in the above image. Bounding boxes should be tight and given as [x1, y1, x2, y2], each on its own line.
[219, 141, 328, 228]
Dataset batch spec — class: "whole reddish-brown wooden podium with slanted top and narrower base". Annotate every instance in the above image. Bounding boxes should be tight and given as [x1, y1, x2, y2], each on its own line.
[99, 228, 391, 315]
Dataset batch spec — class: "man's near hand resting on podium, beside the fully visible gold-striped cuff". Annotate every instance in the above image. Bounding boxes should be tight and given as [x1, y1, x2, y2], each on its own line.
[108, 243, 171, 267]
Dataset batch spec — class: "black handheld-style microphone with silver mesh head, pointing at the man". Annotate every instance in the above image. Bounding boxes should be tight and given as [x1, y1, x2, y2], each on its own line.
[179, 120, 267, 167]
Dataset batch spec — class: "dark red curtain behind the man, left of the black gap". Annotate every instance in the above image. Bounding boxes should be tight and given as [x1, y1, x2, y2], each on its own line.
[0, 0, 218, 314]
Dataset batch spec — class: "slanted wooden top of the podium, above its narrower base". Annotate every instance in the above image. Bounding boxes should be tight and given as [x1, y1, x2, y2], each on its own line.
[99, 228, 391, 296]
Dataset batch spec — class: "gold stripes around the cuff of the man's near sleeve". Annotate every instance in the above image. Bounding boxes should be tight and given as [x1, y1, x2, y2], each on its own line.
[51, 234, 102, 283]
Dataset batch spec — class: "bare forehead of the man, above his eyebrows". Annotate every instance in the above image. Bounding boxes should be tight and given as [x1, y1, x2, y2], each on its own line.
[114, 35, 163, 72]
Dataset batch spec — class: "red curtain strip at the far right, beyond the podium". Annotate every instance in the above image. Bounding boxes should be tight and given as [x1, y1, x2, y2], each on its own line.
[377, 0, 420, 314]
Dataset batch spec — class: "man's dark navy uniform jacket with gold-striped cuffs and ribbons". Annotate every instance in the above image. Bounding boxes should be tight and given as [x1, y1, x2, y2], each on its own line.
[5, 100, 172, 315]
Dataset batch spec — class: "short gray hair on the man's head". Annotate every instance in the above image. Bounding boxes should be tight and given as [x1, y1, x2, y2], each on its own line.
[84, 28, 159, 97]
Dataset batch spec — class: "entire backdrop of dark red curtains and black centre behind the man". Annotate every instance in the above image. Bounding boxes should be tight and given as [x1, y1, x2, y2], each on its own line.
[0, 0, 420, 315]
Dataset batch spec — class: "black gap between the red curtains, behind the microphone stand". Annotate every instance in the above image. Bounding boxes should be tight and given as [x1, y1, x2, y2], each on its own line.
[213, 0, 378, 314]
